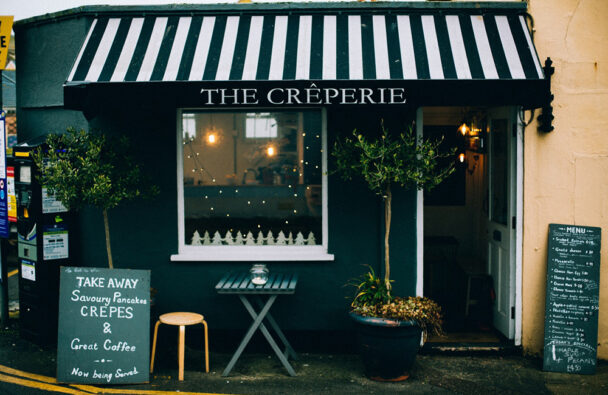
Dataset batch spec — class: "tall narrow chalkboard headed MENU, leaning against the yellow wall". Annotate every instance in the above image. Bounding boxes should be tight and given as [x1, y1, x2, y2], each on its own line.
[543, 224, 601, 374]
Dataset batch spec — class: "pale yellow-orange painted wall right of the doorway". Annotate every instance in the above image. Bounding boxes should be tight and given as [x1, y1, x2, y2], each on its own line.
[522, 0, 608, 359]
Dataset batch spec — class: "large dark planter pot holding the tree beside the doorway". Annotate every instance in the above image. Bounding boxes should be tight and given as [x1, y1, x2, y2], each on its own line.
[350, 313, 422, 381]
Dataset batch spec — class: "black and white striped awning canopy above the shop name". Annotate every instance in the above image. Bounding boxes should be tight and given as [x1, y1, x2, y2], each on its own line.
[66, 11, 544, 85]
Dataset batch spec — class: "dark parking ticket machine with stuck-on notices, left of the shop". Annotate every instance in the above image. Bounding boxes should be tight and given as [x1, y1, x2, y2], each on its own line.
[12, 136, 71, 344]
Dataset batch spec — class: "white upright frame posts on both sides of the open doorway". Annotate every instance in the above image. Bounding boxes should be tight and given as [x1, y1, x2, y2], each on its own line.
[416, 107, 524, 346]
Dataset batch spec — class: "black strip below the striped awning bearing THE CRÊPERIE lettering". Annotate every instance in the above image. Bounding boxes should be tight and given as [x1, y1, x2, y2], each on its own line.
[64, 80, 549, 112]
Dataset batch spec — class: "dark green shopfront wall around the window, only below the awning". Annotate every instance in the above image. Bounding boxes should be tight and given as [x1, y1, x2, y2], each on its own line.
[79, 103, 416, 330]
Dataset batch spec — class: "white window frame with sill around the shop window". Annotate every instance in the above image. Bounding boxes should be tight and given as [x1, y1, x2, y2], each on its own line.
[171, 108, 334, 262]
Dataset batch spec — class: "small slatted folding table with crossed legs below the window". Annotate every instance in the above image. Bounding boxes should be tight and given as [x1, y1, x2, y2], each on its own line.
[215, 272, 298, 376]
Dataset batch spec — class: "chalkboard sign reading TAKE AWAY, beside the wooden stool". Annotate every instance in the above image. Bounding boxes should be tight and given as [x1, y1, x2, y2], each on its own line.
[57, 267, 150, 384]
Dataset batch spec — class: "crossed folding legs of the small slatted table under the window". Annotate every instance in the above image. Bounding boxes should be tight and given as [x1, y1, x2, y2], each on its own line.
[222, 295, 297, 376]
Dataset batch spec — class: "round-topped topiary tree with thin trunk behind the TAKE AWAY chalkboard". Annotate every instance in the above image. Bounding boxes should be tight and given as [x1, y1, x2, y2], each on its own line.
[33, 128, 158, 269]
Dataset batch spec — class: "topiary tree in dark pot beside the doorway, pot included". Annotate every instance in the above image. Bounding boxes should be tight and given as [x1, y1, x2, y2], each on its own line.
[332, 123, 454, 381]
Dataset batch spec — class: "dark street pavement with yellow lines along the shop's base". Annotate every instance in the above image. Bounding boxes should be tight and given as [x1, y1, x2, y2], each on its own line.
[0, 319, 608, 395]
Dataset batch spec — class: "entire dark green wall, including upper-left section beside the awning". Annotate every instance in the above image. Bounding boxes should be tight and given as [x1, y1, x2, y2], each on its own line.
[17, 15, 416, 330]
